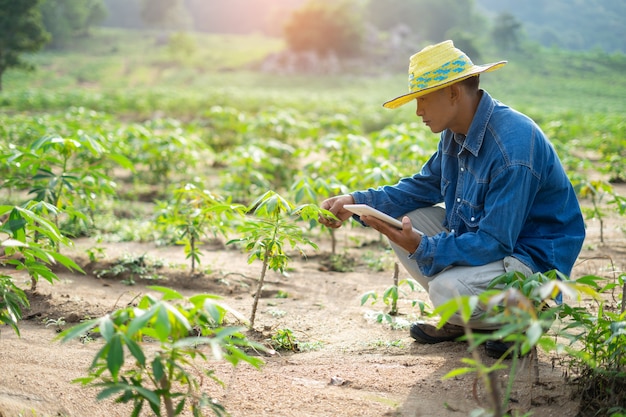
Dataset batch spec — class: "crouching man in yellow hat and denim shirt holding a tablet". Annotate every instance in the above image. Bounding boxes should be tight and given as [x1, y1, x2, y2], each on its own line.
[320, 41, 585, 356]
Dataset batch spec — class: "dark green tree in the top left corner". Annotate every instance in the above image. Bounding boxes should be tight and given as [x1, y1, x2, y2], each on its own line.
[0, 0, 49, 91]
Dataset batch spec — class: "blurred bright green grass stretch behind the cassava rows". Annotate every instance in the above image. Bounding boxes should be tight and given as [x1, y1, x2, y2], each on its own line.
[0, 28, 626, 123]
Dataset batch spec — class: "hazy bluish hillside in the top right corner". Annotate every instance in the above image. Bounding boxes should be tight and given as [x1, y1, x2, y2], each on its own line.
[476, 0, 626, 53]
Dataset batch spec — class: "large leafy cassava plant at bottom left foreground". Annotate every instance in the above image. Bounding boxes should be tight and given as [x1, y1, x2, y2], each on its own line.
[59, 287, 265, 417]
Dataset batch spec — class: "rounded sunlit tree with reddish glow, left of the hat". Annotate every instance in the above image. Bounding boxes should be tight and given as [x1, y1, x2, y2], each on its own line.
[285, 0, 364, 56]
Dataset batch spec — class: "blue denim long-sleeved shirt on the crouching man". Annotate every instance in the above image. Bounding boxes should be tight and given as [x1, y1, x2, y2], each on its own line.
[352, 91, 585, 276]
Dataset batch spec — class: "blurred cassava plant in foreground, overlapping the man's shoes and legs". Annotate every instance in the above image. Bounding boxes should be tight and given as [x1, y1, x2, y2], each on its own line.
[433, 271, 597, 417]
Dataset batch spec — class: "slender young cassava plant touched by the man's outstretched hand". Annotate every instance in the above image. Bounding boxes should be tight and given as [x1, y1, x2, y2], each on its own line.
[228, 191, 321, 329]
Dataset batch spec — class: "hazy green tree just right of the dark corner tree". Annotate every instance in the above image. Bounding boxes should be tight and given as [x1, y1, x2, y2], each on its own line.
[40, 0, 107, 48]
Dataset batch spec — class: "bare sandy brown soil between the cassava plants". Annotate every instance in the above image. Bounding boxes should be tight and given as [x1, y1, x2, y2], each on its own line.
[0, 191, 626, 417]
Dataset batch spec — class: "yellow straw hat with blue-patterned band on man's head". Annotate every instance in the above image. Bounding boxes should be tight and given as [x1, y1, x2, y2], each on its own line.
[383, 41, 506, 109]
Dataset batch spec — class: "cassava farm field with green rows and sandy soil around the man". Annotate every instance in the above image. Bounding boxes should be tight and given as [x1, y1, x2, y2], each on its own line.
[0, 30, 626, 417]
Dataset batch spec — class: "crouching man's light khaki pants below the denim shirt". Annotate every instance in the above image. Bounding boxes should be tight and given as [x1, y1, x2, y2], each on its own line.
[389, 206, 533, 330]
